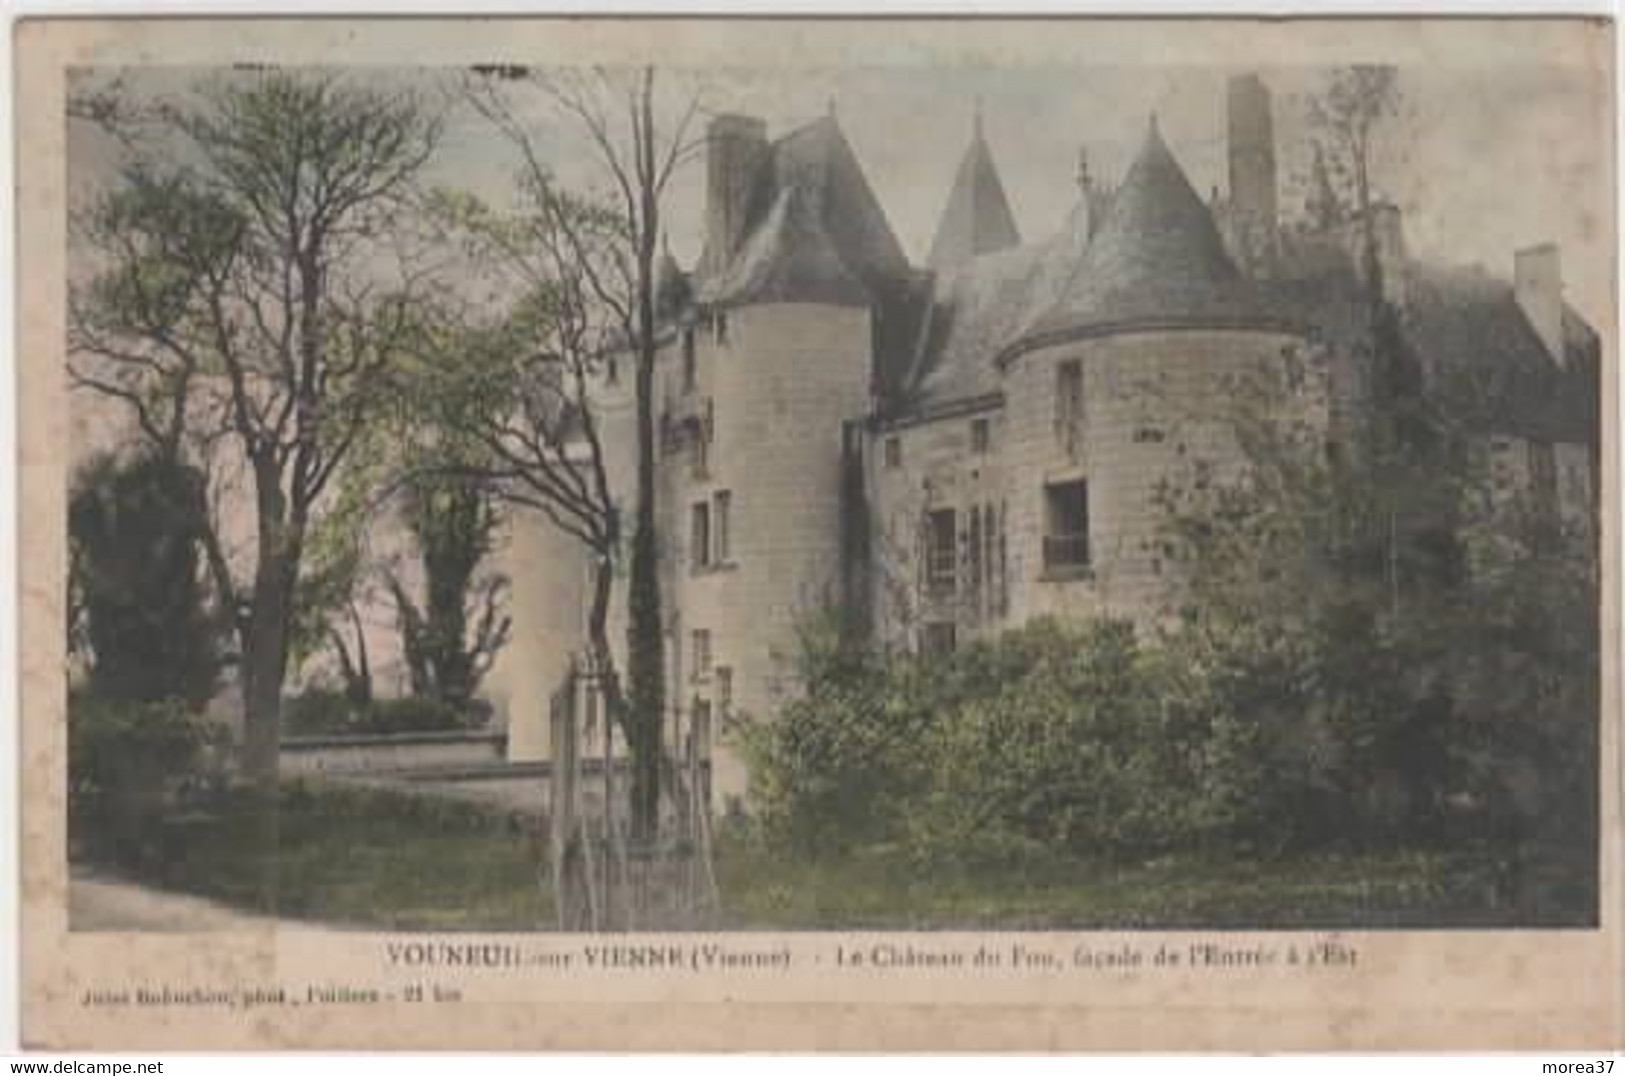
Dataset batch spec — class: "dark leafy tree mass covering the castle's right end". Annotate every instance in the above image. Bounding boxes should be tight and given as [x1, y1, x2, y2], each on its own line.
[1164, 349, 1599, 899]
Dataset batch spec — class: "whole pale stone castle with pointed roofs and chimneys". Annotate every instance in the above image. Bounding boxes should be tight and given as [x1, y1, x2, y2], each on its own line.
[490, 76, 1599, 806]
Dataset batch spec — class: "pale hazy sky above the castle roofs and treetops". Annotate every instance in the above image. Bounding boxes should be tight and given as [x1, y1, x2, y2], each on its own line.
[68, 62, 1614, 333]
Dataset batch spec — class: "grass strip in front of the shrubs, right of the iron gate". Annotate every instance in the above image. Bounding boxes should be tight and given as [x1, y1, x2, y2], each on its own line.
[717, 844, 1576, 930]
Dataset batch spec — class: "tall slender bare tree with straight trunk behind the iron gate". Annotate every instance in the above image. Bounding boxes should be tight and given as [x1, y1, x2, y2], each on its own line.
[468, 67, 699, 839]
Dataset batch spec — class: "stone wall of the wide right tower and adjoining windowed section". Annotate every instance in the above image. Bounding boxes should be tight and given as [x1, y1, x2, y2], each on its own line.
[868, 330, 1306, 647]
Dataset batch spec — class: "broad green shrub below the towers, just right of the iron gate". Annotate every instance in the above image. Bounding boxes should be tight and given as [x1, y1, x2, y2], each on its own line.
[746, 621, 1207, 865]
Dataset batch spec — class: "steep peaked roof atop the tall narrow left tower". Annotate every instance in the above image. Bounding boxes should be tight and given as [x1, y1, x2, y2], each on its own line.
[700, 115, 910, 302]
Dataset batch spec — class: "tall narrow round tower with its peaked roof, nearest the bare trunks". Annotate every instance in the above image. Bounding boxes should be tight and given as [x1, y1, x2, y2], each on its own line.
[661, 117, 907, 806]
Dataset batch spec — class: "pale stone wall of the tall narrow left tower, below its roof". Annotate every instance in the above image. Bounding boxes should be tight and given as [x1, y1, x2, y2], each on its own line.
[661, 304, 871, 803]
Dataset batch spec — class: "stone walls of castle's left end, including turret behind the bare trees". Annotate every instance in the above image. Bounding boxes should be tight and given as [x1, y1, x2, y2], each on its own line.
[502, 304, 871, 805]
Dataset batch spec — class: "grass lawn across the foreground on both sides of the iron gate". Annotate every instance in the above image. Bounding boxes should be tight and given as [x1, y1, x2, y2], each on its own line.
[76, 783, 1588, 931]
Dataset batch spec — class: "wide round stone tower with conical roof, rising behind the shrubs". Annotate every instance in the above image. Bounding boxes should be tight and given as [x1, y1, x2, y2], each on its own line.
[999, 119, 1298, 621]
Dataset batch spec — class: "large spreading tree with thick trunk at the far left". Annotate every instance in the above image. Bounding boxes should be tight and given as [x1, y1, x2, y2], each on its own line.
[70, 70, 440, 790]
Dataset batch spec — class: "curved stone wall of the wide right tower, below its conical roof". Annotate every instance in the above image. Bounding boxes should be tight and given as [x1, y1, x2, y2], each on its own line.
[1004, 330, 1324, 633]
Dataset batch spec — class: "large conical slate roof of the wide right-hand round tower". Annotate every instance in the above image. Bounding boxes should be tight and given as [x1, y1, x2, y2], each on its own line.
[1009, 117, 1269, 353]
